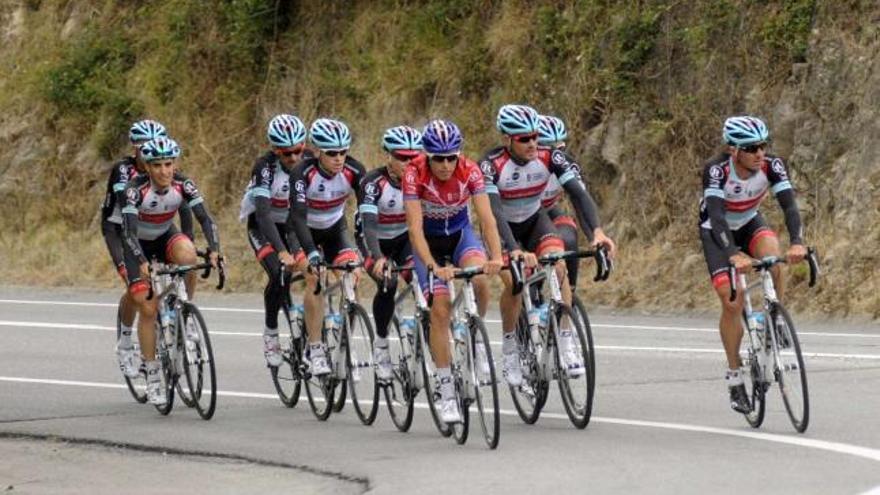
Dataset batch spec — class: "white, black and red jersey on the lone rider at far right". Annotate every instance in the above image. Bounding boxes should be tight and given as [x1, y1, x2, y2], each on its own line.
[700, 153, 802, 257]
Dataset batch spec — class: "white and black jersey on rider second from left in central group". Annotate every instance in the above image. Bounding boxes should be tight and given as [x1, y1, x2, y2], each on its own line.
[288, 156, 366, 254]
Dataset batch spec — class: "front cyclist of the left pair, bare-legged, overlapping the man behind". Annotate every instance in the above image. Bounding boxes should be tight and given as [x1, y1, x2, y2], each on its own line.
[122, 137, 220, 405]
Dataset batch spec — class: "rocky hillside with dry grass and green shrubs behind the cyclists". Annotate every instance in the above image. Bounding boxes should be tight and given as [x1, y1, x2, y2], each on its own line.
[0, 0, 880, 318]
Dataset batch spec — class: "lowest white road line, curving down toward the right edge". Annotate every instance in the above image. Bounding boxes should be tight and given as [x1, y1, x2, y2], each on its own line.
[0, 376, 880, 464]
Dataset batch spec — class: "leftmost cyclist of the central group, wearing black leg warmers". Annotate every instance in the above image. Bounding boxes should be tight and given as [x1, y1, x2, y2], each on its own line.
[239, 114, 306, 367]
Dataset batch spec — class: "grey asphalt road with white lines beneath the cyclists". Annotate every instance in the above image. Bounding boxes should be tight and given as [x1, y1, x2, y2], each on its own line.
[0, 287, 880, 494]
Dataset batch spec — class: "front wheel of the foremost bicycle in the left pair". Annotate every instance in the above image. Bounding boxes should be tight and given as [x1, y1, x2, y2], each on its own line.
[181, 303, 217, 420]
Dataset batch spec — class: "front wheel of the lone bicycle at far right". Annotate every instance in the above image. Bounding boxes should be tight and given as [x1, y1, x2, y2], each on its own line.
[767, 303, 810, 433]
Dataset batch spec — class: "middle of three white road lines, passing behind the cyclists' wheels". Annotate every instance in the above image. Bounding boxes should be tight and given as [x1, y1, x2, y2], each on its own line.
[0, 320, 880, 360]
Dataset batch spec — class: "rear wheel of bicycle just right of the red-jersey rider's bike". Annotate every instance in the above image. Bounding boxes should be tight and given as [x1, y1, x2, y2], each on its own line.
[508, 314, 550, 425]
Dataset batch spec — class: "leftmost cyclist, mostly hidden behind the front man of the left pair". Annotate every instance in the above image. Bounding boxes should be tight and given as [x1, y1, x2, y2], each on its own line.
[101, 119, 192, 378]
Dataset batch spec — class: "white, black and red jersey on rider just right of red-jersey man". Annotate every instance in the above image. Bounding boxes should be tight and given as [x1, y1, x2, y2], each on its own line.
[480, 147, 578, 223]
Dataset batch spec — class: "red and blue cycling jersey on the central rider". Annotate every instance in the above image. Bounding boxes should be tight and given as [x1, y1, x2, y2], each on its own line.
[403, 155, 486, 236]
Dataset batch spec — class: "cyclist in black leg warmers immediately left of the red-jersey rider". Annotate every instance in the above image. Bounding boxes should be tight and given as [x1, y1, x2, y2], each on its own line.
[358, 126, 422, 381]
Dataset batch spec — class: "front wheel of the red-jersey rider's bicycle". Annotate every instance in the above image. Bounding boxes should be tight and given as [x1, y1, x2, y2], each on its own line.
[470, 317, 498, 449]
